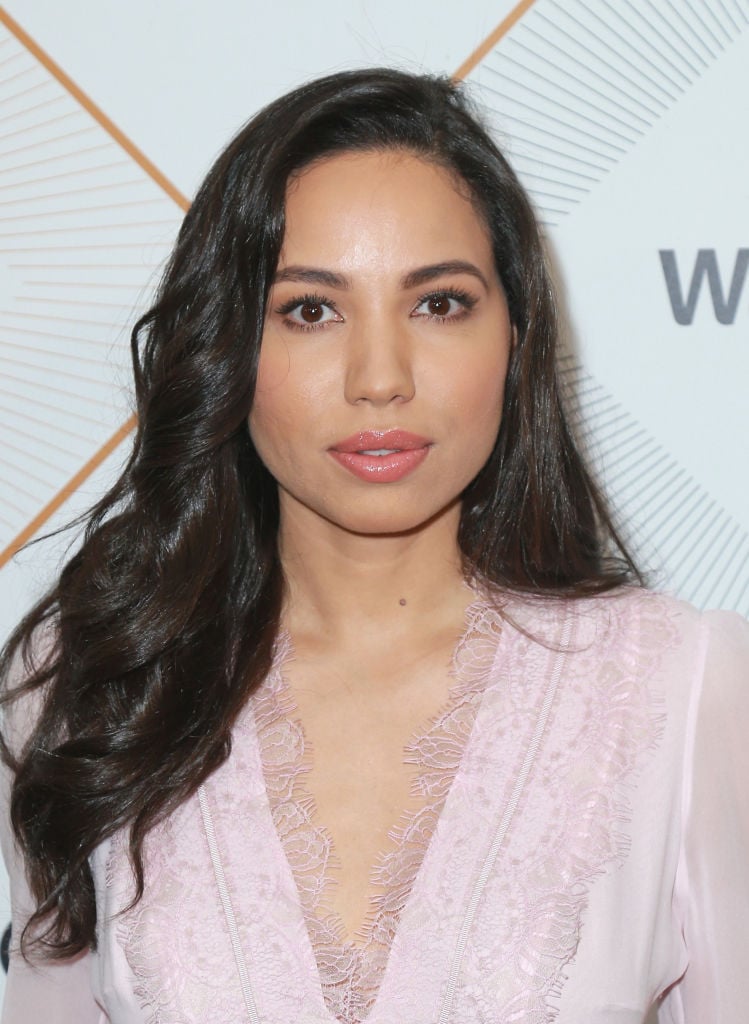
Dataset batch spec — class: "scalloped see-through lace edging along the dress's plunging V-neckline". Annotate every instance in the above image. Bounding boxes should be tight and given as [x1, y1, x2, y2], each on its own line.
[253, 599, 502, 1024]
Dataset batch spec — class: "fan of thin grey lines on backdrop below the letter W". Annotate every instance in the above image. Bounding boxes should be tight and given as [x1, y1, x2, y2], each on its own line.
[559, 354, 749, 616]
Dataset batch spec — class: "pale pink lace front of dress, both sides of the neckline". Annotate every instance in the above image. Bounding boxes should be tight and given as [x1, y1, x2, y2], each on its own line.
[103, 592, 680, 1024]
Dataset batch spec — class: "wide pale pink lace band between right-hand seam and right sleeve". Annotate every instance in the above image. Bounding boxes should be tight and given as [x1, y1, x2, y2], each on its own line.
[455, 594, 677, 1024]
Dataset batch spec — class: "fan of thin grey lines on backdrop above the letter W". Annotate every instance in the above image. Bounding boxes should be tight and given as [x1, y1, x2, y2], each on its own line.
[468, 0, 749, 227]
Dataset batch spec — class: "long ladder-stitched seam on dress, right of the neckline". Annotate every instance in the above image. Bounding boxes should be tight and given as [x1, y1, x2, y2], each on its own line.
[438, 614, 572, 1024]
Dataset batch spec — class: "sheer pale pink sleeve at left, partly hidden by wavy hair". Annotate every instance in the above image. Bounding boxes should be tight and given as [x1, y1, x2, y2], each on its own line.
[0, 643, 108, 1024]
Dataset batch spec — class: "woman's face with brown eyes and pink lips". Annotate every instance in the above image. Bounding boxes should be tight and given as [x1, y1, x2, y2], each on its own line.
[249, 152, 512, 534]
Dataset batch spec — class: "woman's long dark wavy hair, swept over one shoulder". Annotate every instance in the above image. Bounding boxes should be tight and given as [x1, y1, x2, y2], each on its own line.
[0, 69, 639, 957]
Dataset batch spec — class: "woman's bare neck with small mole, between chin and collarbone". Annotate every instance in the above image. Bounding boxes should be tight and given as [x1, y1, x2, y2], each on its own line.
[280, 497, 472, 646]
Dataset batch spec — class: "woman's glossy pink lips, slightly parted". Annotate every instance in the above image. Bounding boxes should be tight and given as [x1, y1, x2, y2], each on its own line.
[329, 430, 431, 483]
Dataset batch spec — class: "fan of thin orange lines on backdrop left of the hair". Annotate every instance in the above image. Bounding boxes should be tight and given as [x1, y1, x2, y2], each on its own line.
[0, 27, 183, 550]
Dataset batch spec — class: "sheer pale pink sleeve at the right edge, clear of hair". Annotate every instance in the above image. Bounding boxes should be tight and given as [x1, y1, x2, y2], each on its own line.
[662, 612, 749, 1024]
